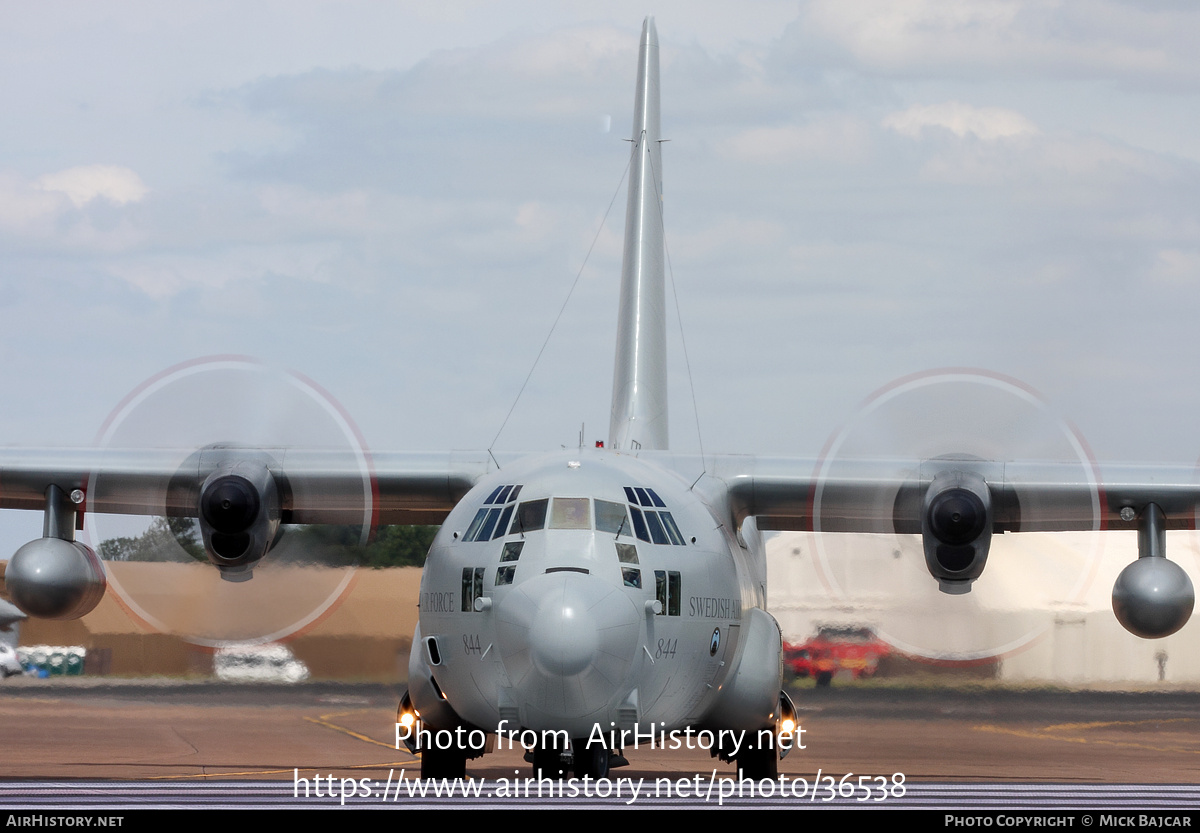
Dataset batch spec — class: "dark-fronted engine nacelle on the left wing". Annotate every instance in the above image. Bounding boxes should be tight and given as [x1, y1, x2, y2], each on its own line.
[197, 461, 281, 581]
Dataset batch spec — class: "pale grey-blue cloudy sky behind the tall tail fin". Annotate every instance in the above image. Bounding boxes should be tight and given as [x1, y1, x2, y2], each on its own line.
[0, 0, 1200, 528]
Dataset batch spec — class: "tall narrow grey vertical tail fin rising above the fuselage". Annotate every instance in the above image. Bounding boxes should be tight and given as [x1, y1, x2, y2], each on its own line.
[608, 17, 667, 449]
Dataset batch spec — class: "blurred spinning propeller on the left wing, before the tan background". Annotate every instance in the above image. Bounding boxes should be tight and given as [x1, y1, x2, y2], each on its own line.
[84, 356, 374, 647]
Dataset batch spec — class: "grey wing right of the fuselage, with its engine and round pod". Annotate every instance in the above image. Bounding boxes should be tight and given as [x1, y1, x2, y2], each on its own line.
[691, 456, 1200, 639]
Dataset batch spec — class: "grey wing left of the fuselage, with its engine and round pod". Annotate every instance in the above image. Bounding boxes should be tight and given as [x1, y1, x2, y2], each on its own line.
[0, 445, 488, 619]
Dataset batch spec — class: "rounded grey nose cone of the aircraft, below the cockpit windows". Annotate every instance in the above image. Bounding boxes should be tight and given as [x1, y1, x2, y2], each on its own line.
[496, 570, 641, 720]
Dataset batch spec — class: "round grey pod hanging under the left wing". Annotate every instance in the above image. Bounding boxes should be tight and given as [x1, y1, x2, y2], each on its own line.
[5, 538, 108, 619]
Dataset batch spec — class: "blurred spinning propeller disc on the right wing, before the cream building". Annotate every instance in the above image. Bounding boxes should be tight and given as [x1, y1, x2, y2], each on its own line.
[812, 370, 1103, 661]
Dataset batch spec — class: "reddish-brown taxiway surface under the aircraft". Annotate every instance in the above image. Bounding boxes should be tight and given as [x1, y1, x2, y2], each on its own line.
[0, 679, 1200, 784]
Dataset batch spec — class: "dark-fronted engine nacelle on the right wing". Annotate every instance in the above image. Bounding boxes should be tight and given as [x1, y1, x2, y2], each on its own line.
[920, 472, 992, 595]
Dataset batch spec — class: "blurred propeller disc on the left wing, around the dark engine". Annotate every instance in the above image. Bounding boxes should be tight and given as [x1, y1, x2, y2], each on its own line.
[84, 356, 376, 647]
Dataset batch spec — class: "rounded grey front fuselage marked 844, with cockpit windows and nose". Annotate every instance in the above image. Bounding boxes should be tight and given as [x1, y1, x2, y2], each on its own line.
[409, 449, 779, 758]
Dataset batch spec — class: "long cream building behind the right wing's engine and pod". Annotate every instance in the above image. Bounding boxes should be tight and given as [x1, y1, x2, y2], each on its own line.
[767, 532, 1200, 687]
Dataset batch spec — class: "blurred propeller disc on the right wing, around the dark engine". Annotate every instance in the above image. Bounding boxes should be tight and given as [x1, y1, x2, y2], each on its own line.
[812, 368, 1103, 663]
